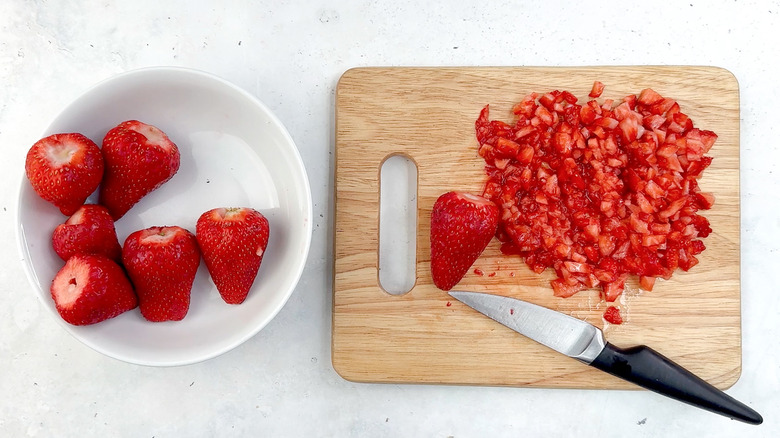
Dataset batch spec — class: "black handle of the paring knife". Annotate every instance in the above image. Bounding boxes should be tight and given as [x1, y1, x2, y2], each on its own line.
[590, 343, 764, 424]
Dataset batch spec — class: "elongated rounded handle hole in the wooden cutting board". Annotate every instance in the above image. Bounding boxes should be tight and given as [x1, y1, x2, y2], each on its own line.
[378, 154, 417, 295]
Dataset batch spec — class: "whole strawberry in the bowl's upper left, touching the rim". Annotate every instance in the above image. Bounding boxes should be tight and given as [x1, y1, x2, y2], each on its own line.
[25, 133, 104, 216]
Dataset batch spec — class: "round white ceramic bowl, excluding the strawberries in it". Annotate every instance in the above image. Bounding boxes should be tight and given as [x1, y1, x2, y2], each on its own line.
[17, 68, 312, 366]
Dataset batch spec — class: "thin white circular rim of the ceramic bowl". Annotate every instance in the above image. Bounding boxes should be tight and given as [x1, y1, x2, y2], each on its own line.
[13, 66, 314, 367]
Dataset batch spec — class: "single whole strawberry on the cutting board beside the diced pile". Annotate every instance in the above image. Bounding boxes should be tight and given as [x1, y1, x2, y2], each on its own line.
[431, 192, 498, 290]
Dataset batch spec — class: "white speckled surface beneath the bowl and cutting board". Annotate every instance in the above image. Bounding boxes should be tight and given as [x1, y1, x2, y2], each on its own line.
[0, 0, 780, 437]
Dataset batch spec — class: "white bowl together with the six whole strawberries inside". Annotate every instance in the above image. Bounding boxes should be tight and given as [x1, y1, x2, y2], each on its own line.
[17, 67, 312, 366]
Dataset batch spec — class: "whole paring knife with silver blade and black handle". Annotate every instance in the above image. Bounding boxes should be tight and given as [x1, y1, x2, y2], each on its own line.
[450, 291, 764, 424]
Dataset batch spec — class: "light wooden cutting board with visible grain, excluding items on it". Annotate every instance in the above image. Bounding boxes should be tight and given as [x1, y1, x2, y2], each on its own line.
[332, 66, 741, 388]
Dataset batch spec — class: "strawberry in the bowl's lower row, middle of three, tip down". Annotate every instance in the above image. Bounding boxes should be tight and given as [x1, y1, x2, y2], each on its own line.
[122, 226, 200, 322]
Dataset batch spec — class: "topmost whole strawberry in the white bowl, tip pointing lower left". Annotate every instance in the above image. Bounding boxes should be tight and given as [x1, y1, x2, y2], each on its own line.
[100, 120, 179, 220]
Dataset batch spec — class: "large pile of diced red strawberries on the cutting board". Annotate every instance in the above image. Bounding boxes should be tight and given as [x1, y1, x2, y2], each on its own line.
[475, 82, 717, 301]
